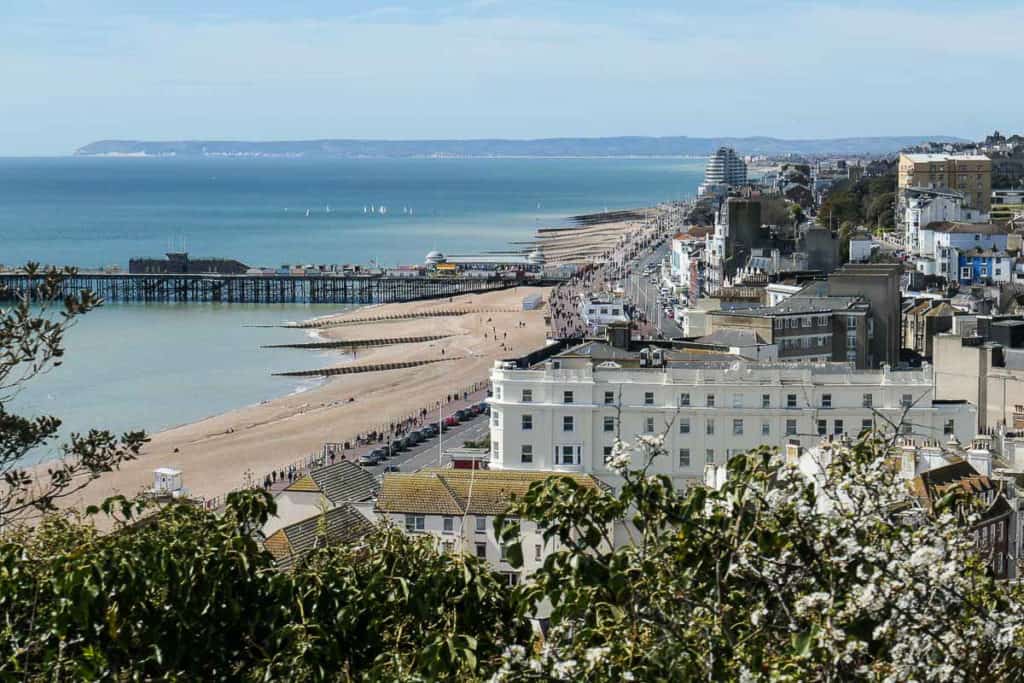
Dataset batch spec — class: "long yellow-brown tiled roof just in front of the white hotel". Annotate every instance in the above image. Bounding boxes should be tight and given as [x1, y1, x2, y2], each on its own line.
[376, 468, 606, 516]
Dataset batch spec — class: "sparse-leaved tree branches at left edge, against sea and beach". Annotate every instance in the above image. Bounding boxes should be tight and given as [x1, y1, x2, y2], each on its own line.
[0, 263, 145, 529]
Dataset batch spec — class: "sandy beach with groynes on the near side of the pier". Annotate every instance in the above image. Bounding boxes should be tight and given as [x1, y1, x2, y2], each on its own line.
[56, 287, 548, 516]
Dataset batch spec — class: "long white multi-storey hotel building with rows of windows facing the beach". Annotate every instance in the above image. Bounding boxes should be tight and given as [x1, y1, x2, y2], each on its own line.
[488, 341, 976, 485]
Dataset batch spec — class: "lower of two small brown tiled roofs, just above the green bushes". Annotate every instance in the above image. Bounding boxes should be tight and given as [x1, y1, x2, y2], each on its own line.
[263, 505, 374, 569]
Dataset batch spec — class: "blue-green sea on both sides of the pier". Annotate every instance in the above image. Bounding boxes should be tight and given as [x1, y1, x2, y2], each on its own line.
[0, 158, 703, 461]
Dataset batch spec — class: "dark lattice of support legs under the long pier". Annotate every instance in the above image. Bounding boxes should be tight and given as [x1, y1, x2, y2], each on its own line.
[0, 272, 528, 304]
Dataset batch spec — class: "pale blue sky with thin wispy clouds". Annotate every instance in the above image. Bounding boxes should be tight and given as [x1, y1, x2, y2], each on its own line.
[0, 0, 1024, 156]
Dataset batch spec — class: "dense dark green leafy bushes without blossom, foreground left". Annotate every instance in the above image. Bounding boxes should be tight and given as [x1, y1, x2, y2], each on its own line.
[0, 492, 529, 680]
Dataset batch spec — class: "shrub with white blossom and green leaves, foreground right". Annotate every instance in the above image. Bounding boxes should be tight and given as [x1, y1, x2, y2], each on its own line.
[494, 437, 1024, 681]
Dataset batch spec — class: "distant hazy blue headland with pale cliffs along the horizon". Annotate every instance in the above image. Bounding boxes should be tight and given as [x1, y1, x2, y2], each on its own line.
[74, 135, 964, 159]
